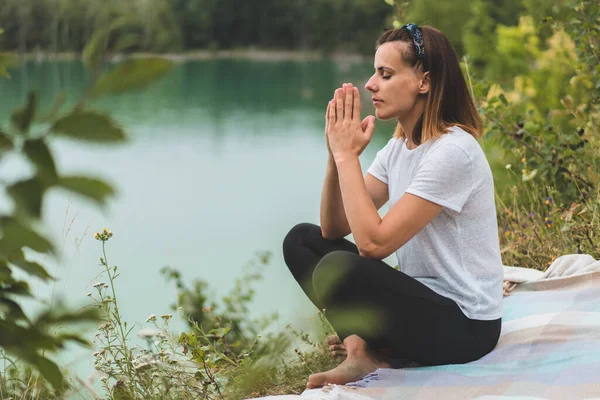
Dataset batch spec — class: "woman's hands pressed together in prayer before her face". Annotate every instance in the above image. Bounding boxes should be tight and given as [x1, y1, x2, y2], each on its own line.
[325, 84, 375, 162]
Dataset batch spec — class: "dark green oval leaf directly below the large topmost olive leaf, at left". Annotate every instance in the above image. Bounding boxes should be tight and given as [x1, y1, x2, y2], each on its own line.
[51, 111, 125, 142]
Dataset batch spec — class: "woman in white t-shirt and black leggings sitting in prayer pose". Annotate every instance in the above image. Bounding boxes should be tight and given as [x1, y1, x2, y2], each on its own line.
[283, 24, 502, 388]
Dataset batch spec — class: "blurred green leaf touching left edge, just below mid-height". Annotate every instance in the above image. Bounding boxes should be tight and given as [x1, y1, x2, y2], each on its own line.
[0, 217, 54, 254]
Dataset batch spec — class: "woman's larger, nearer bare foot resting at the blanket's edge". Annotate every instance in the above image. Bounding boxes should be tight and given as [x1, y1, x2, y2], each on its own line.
[306, 351, 390, 389]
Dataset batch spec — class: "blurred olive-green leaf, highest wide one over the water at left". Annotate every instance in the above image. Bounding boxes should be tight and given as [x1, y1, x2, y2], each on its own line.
[90, 57, 173, 97]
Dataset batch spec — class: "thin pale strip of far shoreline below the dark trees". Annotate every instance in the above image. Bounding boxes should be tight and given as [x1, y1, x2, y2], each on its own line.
[12, 49, 372, 63]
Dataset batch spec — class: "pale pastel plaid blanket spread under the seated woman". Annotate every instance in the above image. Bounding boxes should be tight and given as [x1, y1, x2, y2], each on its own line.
[253, 255, 600, 400]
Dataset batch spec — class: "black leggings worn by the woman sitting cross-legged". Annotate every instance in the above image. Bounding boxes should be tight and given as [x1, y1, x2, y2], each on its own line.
[283, 223, 501, 365]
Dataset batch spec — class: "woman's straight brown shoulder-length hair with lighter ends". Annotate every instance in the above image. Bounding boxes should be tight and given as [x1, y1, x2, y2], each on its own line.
[376, 26, 483, 145]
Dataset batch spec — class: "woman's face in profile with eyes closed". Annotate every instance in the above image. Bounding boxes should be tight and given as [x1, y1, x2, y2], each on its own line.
[365, 42, 429, 120]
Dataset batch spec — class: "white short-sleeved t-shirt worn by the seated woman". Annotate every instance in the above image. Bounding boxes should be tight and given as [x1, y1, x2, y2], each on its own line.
[367, 127, 503, 320]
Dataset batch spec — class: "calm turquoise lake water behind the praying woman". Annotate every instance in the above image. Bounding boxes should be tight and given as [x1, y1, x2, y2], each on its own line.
[0, 60, 406, 384]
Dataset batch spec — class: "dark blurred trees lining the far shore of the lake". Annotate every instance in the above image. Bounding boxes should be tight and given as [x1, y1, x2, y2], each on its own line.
[0, 0, 391, 52]
